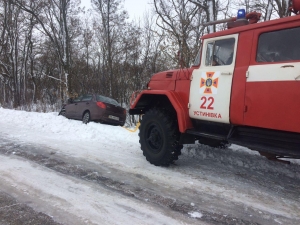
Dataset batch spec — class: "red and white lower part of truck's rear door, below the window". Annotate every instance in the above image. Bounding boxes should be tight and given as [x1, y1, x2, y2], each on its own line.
[244, 62, 300, 132]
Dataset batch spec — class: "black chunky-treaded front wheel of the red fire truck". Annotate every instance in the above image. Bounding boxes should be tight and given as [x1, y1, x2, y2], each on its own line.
[139, 108, 182, 166]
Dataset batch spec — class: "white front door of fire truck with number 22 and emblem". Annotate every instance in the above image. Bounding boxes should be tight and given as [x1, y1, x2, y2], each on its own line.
[189, 34, 238, 123]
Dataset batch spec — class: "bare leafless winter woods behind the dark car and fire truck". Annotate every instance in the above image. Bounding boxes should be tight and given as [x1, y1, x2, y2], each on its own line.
[0, 0, 290, 111]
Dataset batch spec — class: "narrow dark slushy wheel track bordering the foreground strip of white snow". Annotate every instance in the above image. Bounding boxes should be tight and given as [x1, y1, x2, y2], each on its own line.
[0, 137, 259, 225]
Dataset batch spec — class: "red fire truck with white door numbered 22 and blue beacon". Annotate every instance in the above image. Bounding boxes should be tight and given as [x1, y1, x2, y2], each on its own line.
[129, 0, 300, 166]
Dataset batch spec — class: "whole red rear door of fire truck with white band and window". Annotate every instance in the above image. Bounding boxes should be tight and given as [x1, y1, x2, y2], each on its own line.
[244, 24, 300, 132]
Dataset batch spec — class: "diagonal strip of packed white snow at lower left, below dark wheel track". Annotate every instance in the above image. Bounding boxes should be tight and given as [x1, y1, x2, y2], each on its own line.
[0, 156, 183, 225]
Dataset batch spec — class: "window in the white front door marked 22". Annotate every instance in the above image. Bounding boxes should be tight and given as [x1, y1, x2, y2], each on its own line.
[205, 38, 235, 66]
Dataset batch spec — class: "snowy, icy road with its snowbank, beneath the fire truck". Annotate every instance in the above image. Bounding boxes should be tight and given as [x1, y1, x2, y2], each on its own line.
[0, 108, 300, 225]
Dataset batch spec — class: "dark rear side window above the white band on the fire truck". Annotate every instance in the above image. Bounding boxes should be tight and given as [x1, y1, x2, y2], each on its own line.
[256, 27, 300, 63]
